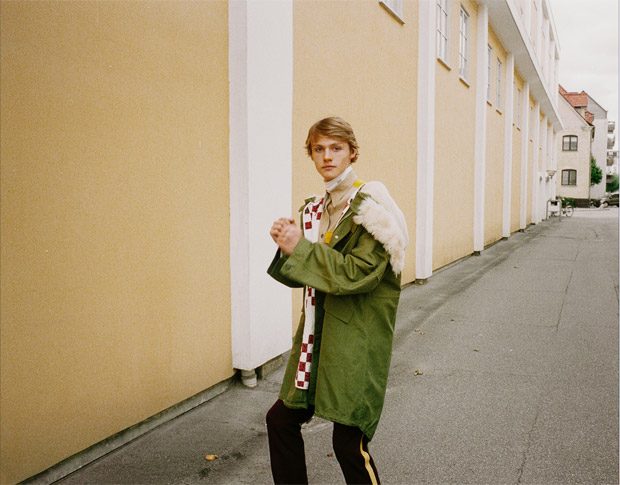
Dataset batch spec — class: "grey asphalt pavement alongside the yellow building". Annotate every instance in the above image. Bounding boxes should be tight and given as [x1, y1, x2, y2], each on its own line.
[55, 208, 619, 485]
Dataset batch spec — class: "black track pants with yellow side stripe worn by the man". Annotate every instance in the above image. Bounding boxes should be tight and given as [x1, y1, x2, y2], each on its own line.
[267, 399, 380, 485]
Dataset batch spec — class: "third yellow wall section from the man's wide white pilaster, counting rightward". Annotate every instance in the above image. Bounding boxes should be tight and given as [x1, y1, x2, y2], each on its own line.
[484, 29, 507, 245]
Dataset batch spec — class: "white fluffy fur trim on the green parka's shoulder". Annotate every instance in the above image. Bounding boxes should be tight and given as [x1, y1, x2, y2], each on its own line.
[353, 181, 409, 275]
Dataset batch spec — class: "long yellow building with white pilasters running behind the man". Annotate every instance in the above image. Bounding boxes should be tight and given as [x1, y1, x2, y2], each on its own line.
[0, 0, 562, 482]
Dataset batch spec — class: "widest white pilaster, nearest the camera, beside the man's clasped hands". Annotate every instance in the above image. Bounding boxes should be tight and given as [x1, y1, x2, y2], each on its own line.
[228, 0, 293, 370]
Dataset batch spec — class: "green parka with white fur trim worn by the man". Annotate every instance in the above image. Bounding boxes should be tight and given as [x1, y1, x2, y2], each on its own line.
[268, 182, 407, 439]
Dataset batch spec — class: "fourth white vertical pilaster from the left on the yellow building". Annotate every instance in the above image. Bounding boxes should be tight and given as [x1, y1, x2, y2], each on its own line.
[502, 52, 515, 237]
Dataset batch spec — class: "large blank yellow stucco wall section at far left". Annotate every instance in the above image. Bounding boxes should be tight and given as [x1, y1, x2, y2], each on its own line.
[0, 1, 232, 483]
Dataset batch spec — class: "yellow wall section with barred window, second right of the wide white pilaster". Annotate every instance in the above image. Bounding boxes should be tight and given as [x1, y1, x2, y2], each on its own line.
[433, 2, 477, 269]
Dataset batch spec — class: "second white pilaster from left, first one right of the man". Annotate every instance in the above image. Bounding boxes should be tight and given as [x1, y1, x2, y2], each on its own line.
[415, 2, 436, 280]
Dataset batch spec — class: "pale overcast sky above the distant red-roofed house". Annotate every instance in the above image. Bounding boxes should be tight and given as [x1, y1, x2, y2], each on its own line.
[550, 0, 620, 146]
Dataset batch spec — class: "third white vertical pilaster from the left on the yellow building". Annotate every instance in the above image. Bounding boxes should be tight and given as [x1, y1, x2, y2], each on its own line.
[474, 2, 489, 251]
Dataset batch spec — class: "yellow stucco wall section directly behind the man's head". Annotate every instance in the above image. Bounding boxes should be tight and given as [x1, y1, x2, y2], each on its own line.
[292, 0, 418, 286]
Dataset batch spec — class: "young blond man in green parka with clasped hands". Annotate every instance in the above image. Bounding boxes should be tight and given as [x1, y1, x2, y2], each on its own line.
[267, 118, 408, 484]
